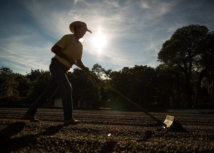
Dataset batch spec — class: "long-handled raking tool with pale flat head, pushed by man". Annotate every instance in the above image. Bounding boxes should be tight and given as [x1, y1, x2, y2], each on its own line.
[90, 73, 186, 132]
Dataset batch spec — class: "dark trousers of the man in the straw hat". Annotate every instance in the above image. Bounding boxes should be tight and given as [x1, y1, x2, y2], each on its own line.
[27, 58, 73, 120]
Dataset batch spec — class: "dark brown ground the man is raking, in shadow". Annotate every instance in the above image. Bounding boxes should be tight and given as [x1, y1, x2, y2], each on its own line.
[0, 108, 214, 153]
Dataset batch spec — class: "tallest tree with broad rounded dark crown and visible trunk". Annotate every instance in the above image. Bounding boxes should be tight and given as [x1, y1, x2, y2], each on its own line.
[158, 25, 211, 108]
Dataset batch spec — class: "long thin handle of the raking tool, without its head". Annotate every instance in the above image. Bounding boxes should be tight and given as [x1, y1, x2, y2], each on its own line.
[90, 73, 166, 127]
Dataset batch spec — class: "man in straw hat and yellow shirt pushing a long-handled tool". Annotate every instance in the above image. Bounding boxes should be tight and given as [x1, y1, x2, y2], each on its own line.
[24, 21, 92, 124]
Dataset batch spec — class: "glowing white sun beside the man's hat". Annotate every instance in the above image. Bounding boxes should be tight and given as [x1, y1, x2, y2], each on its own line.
[93, 29, 107, 52]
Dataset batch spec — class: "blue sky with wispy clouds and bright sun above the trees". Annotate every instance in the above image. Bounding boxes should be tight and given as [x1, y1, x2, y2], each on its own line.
[0, 0, 214, 75]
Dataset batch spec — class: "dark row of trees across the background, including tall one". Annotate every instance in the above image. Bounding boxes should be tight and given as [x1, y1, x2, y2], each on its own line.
[0, 25, 214, 110]
